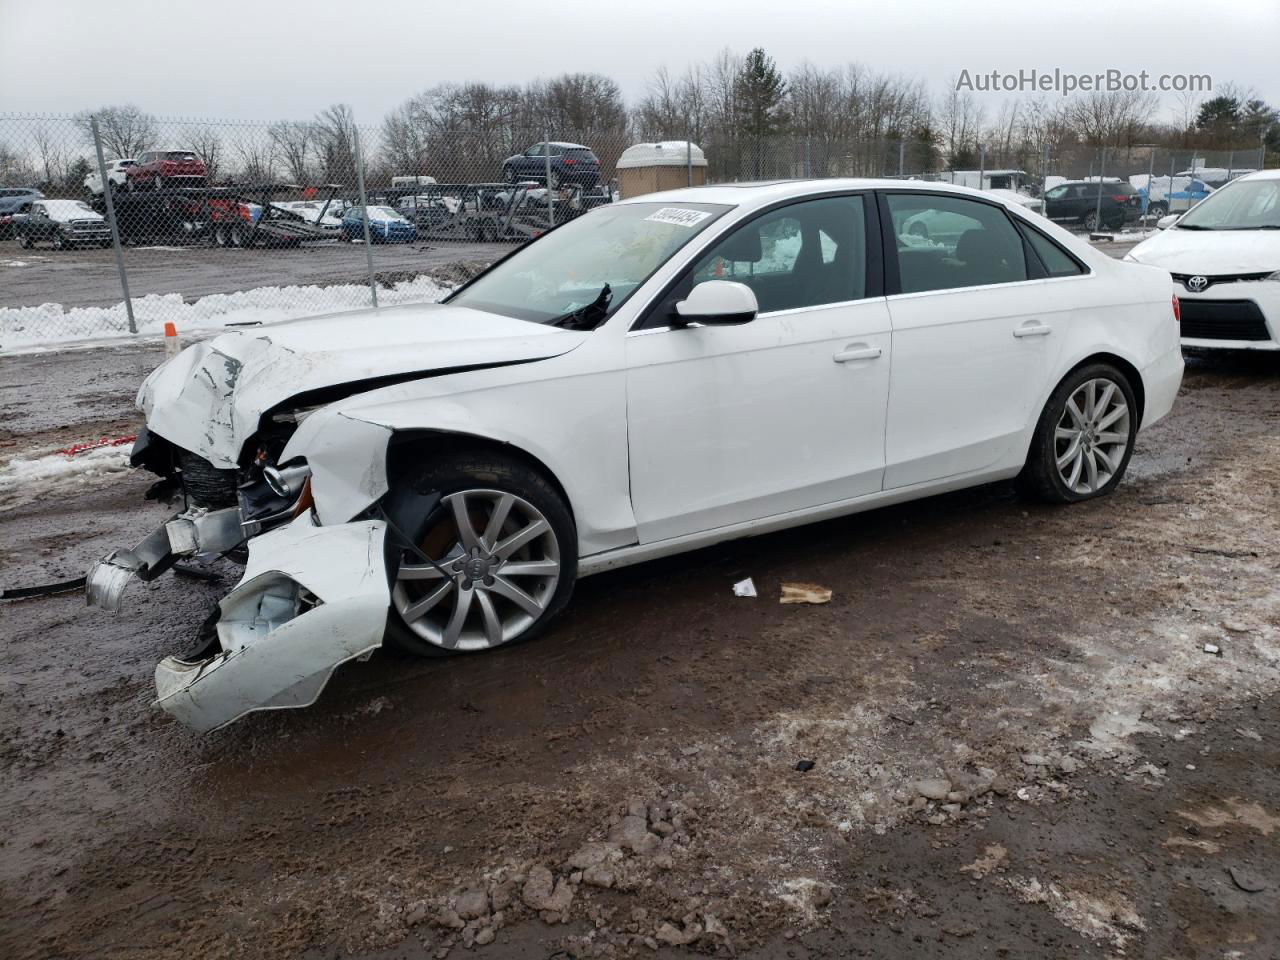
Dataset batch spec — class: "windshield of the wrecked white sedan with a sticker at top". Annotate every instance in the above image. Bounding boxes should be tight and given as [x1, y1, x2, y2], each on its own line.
[449, 201, 731, 329]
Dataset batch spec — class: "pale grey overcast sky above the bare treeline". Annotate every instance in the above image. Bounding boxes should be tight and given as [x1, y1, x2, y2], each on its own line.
[0, 0, 1280, 123]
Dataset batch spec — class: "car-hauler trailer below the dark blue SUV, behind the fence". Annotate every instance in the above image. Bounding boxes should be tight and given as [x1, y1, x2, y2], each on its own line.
[370, 180, 611, 242]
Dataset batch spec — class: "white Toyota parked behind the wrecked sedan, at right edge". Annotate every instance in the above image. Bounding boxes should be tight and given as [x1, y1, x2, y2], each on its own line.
[1125, 170, 1280, 351]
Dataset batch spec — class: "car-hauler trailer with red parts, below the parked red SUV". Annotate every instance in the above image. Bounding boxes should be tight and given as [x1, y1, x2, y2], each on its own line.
[93, 183, 342, 247]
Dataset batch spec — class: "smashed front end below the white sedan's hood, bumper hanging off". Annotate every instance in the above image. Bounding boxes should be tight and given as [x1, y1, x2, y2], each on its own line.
[86, 417, 390, 732]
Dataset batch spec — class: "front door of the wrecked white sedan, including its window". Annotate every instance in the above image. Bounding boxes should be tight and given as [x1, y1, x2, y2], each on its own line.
[626, 193, 891, 543]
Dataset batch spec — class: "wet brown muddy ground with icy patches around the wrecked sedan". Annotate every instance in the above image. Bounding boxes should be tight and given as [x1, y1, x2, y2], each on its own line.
[0, 317, 1280, 960]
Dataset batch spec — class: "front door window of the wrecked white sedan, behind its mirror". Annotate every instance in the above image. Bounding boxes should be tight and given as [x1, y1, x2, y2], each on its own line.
[690, 196, 867, 314]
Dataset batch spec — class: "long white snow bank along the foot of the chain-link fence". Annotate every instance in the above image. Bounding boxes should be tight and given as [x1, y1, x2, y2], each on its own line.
[0, 276, 451, 353]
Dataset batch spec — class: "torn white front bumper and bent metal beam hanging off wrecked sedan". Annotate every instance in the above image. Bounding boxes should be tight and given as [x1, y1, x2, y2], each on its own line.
[86, 508, 390, 733]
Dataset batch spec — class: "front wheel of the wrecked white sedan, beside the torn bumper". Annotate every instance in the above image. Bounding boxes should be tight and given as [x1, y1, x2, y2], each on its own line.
[387, 452, 577, 657]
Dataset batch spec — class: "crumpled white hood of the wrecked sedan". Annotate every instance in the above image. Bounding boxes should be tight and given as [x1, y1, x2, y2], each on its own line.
[138, 303, 589, 468]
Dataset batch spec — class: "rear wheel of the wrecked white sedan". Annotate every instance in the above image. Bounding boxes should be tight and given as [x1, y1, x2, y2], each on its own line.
[1018, 364, 1139, 503]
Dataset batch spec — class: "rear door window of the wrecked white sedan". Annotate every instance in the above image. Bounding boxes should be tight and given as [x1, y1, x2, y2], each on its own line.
[886, 193, 1028, 293]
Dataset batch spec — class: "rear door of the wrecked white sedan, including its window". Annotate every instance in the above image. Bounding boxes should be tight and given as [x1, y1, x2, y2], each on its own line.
[881, 192, 1068, 489]
